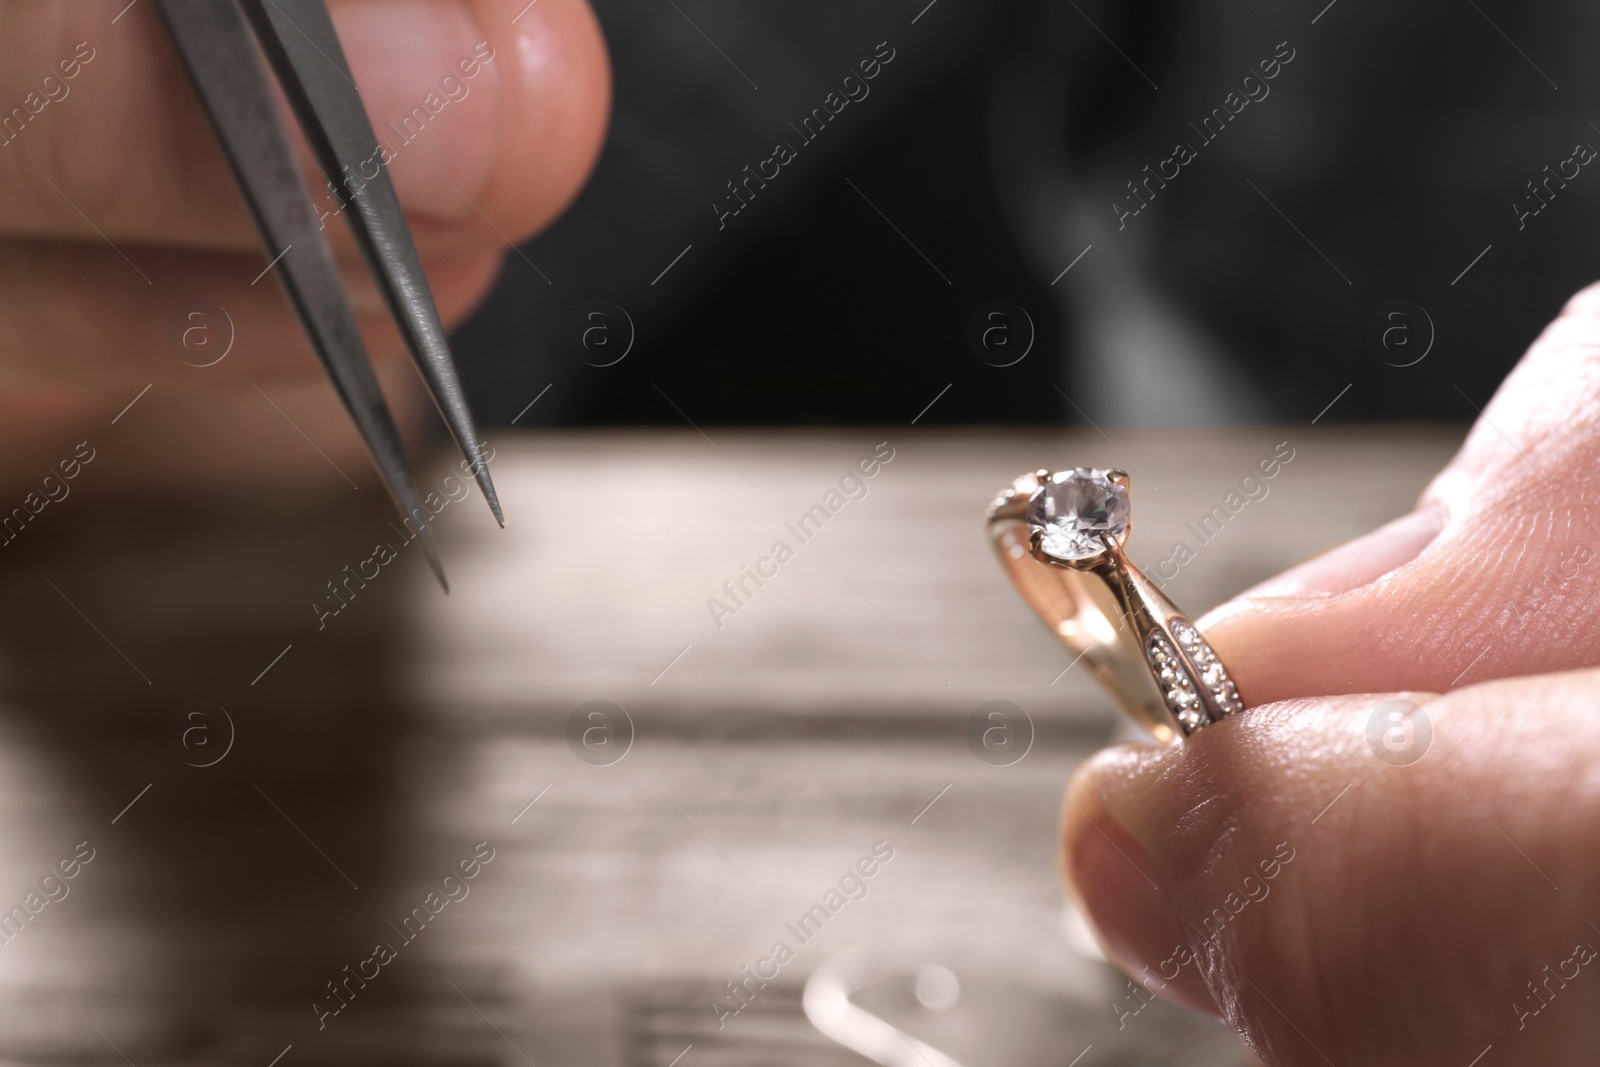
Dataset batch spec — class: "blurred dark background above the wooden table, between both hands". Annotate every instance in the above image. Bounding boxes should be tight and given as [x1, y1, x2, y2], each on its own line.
[458, 0, 1600, 426]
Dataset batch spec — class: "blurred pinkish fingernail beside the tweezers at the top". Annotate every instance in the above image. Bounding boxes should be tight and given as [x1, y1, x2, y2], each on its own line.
[333, 0, 502, 221]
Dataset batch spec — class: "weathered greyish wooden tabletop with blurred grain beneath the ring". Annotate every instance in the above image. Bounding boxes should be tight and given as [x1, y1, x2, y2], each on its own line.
[0, 427, 1461, 1067]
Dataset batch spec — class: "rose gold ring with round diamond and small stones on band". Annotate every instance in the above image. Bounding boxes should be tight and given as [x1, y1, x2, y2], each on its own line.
[987, 467, 1245, 742]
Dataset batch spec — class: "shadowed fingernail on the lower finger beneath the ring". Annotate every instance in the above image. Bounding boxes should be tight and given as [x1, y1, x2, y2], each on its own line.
[1066, 790, 1216, 1013]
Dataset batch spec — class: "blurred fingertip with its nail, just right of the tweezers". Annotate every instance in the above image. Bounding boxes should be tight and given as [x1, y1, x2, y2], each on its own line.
[334, 0, 611, 241]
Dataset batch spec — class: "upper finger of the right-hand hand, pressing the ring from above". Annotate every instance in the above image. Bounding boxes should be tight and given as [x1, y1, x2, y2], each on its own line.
[1202, 279, 1600, 704]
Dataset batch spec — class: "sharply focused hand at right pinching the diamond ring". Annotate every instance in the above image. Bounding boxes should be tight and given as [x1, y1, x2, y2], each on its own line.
[1064, 279, 1600, 1067]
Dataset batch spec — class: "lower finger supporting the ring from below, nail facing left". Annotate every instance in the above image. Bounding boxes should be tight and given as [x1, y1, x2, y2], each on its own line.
[1064, 670, 1600, 1067]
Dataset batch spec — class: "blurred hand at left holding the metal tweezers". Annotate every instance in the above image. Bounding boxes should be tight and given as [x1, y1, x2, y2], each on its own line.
[0, 0, 610, 483]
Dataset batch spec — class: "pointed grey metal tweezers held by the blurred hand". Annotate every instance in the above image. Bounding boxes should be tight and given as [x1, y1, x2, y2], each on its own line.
[155, 0, 506, 592]
